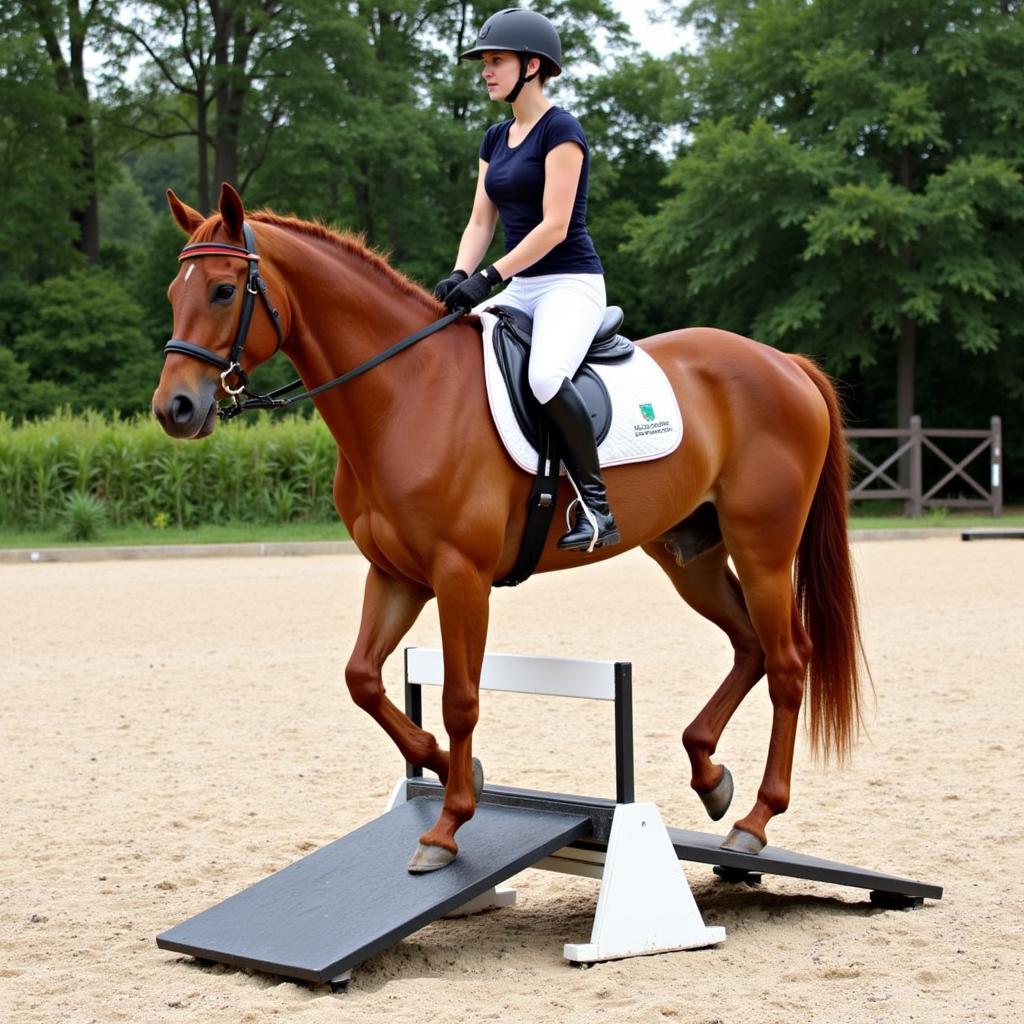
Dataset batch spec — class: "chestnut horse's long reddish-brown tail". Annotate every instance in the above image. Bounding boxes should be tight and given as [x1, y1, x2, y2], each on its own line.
[793, 355, 866, 763]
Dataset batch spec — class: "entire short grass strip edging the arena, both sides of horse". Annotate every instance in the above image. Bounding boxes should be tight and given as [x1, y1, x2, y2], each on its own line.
[0, 507, 1024, 548]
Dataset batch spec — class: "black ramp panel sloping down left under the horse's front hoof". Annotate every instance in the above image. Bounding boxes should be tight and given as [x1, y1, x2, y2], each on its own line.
[157, 797, 591, 983]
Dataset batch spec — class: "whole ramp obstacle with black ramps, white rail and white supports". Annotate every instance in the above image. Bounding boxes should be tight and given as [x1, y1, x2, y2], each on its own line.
[157, 648, 942, 987]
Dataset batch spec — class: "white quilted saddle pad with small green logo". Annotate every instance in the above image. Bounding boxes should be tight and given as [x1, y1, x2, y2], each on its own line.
[478, 312, 683, 473]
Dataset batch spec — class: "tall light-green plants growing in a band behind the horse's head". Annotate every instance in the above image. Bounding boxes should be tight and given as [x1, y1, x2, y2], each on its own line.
[0, 410, 337, 529]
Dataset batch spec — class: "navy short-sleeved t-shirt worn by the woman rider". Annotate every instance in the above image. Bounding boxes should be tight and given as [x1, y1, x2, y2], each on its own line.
[480, 106, 604, 278]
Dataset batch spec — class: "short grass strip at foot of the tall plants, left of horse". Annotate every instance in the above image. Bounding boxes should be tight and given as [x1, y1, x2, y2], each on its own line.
[0, 519, 348, 548]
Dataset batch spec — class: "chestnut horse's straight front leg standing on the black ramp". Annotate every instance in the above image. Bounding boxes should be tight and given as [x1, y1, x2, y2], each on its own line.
[409, 554, 492, 873]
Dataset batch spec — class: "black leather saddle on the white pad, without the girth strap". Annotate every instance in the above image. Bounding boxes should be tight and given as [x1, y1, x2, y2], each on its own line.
[486, 305, 634, 452]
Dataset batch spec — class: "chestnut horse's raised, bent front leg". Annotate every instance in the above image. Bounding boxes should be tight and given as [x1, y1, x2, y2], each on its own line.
[345, 565, 449, 782]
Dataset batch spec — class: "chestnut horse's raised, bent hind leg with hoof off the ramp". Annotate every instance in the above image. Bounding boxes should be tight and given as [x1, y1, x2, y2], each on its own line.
[644, 541, 764, 821]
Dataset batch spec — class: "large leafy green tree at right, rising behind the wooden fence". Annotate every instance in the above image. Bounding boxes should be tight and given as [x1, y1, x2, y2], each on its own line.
[634, 0, 1024, 436]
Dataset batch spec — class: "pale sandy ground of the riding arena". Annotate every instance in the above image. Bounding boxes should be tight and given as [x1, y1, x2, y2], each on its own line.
[0, 540, 1024, 1024]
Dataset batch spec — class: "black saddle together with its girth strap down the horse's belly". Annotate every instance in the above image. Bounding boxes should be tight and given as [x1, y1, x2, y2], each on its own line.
[486, 305, 634, 587]
